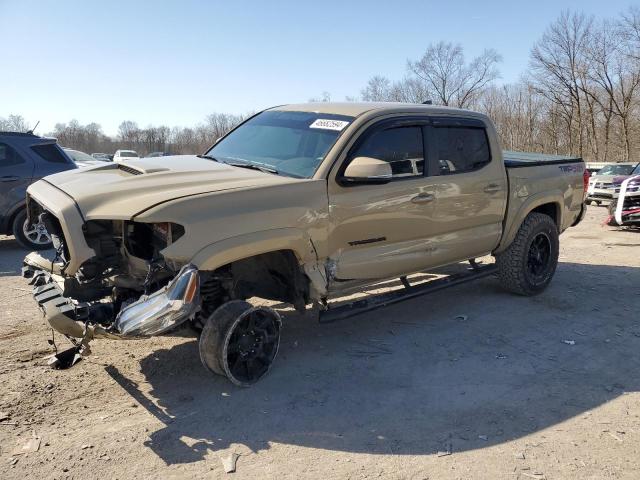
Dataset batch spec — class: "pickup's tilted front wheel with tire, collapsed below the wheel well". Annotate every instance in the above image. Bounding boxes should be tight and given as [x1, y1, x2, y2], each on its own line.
[198, 300, 282, 387]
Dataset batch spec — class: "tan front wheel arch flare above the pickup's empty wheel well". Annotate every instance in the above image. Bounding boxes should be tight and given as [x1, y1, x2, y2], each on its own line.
[191, 228, 327, 294]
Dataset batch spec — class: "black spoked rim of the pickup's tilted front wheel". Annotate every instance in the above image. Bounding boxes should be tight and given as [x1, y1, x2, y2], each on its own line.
[224, 308, 280, 384]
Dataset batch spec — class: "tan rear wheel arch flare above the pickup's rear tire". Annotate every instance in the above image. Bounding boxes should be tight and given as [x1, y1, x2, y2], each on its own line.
[494, 189, 568, 253]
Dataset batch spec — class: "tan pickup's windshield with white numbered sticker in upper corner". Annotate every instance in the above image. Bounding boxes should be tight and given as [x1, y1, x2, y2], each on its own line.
[207, 110, 353, 178]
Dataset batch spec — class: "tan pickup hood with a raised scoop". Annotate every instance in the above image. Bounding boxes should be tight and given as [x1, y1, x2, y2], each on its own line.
[44, 155, 296, 220]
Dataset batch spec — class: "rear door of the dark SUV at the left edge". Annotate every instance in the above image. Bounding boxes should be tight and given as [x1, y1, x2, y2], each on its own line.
[0, 142, 33, 217]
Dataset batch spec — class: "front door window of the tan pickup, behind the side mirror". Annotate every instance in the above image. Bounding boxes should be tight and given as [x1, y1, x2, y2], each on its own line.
[350, 126, 424, 178]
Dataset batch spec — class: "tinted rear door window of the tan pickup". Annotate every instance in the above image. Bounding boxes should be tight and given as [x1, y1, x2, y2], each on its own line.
[433, 127, 491, 175]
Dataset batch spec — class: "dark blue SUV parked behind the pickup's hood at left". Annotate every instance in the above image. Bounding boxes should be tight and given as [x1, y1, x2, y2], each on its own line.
[0, 132, 77, 250]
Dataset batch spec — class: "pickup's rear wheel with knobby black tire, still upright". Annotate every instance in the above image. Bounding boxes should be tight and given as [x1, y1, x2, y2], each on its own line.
[496, 213, 560, 296]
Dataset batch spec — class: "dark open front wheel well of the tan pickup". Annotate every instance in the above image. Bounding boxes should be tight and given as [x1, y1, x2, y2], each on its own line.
[208, 250, 309, 311]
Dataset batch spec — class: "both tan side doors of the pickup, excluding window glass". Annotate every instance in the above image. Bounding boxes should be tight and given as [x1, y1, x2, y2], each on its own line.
[328, 109, 507, 284]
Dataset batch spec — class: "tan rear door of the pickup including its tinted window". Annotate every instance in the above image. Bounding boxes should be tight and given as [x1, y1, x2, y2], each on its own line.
[427, 117, 508, 263]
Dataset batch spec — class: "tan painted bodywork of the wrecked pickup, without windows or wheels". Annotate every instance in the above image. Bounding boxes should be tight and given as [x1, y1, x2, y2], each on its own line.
[29, 103, 583, 299]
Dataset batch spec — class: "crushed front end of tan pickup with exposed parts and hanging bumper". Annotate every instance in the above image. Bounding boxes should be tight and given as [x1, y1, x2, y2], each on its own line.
[22, 191, 201, 367]
